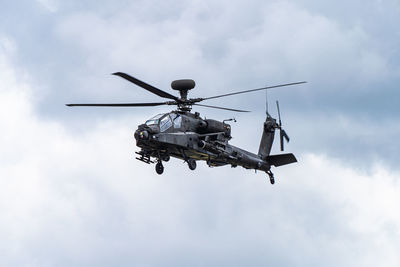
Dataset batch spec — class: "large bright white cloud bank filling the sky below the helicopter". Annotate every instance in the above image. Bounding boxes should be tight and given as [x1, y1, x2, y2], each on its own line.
[0, 34, 400, 266]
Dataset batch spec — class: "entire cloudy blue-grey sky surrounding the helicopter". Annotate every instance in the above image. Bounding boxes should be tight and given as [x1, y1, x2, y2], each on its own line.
[0, 0, 400, 266]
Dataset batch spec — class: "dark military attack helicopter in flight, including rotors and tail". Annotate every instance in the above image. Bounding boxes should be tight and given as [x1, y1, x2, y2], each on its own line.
[66, 72, 305, 184]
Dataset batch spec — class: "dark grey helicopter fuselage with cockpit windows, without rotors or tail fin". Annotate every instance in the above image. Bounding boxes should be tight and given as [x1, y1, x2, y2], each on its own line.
[135, 111, 271, 171]
